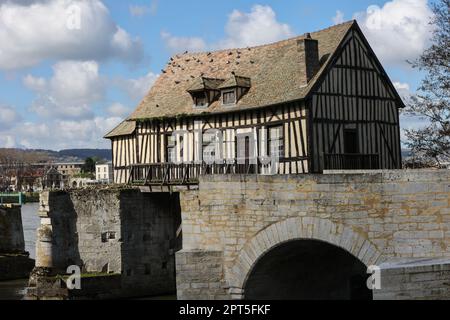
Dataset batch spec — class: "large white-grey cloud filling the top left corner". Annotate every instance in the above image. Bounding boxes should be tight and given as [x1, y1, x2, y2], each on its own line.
[0, 0, 142, 70]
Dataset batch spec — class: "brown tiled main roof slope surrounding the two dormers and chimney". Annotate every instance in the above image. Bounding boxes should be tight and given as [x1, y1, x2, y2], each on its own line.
[130, 21, 355, 120]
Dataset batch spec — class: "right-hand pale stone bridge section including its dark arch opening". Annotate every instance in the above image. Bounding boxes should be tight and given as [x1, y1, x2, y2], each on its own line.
[176, 171, 450, 299]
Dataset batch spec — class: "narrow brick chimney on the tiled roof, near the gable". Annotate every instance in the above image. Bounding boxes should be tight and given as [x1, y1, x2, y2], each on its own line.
[297, 33, 320, 85]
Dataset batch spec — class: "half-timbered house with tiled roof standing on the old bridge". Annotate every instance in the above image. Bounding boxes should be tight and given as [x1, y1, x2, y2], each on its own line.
[106, 21, 404, 184]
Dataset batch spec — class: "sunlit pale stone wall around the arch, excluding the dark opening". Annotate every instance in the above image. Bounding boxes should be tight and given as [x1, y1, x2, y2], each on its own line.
[177, 170, 450, 299]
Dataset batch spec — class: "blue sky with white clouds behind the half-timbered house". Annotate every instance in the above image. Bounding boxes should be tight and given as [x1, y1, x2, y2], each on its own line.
[0, 0, 432, 150]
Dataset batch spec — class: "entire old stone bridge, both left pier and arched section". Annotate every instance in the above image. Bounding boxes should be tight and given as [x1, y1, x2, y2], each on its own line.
[30, 170, 450, 299]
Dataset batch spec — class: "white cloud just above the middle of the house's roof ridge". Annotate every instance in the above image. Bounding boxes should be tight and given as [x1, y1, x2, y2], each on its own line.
[161, 5, 293, 52]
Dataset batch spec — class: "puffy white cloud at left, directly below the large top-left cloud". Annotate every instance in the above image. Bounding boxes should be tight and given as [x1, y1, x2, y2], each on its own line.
[24, 61, 105, 119]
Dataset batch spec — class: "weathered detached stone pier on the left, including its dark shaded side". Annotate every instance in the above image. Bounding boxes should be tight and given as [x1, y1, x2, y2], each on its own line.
[31, 187, 180, 298]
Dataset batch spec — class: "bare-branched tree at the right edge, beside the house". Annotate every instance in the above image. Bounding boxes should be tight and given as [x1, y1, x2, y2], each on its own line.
[405, 0, 450, 163]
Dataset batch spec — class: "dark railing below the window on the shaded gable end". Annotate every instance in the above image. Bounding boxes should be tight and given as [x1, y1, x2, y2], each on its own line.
[324, 153, 380, 170]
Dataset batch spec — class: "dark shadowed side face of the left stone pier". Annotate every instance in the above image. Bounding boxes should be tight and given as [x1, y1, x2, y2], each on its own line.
[120, 192, 181, 297]
